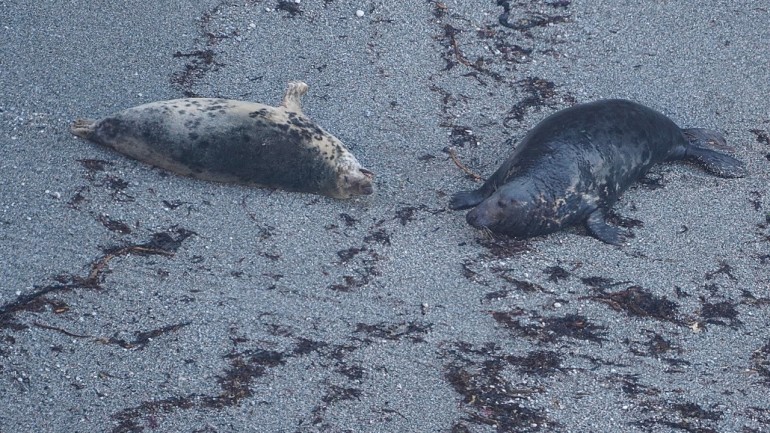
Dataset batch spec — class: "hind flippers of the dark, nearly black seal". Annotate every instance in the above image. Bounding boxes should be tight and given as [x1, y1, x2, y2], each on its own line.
[682, 128, 747, 177]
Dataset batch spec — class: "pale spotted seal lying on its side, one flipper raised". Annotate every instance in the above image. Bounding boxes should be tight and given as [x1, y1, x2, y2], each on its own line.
[71, 82, 374, 198]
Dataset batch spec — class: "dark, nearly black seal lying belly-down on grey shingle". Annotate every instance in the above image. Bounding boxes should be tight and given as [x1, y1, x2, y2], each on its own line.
[450, 100, 746, 245]
